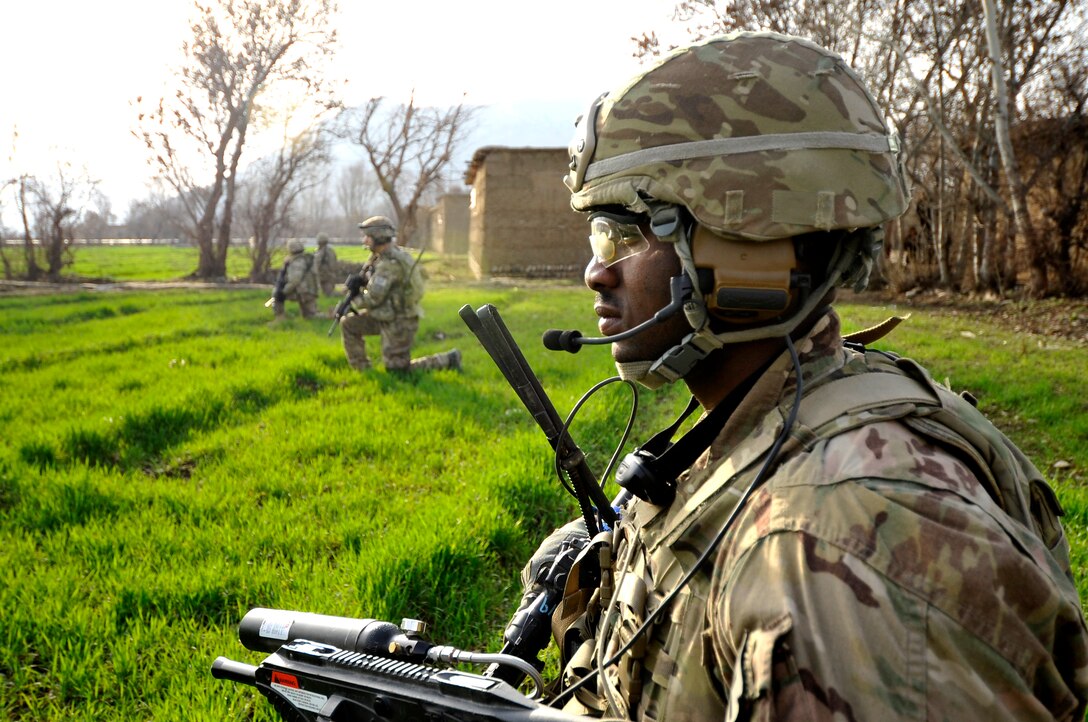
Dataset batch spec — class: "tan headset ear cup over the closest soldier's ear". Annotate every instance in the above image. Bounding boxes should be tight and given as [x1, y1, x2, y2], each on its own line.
[691, 225, 798, 325]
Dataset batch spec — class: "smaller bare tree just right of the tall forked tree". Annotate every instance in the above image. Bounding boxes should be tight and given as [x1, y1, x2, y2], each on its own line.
[242, 118, 329, 282]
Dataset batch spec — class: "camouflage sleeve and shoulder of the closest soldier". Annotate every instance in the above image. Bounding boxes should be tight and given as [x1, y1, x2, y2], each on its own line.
[709, 480, 1086, 720]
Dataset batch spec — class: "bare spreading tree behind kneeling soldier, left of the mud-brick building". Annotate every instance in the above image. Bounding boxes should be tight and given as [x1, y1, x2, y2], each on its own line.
[341, 96, 477, 245]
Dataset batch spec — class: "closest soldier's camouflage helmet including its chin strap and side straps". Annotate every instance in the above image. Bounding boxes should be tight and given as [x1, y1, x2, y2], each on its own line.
[564, 33, 907, 385]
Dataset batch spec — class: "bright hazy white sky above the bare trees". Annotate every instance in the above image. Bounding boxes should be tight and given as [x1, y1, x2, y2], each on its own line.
[0, 0, 682, 215]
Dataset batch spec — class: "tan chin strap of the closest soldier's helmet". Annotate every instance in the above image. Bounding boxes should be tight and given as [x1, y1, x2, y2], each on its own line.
[616, 223, 863, 389]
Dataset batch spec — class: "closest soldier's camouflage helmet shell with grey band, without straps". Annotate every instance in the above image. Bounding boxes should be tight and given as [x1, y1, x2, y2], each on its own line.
[565, 33, 906, 240]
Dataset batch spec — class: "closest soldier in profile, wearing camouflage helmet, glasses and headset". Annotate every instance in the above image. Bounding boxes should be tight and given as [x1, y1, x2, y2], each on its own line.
[523, 34, 1088, 721]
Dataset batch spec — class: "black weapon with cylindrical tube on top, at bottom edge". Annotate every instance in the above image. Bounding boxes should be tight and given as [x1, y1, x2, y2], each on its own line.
[211, 608, 586, 722]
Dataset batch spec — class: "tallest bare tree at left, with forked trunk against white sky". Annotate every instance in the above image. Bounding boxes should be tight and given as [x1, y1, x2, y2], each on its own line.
[137, 0, 336, 278]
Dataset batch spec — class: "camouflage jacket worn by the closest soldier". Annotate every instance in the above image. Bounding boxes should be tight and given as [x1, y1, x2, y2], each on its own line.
[567, 312, 1088, 722]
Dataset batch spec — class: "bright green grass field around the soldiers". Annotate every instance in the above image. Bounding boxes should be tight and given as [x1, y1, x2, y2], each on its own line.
[0, 246, 1088, 721]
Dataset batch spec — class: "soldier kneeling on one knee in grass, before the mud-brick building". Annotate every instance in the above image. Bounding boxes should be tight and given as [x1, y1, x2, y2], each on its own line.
[339, 215, 461, 373]
